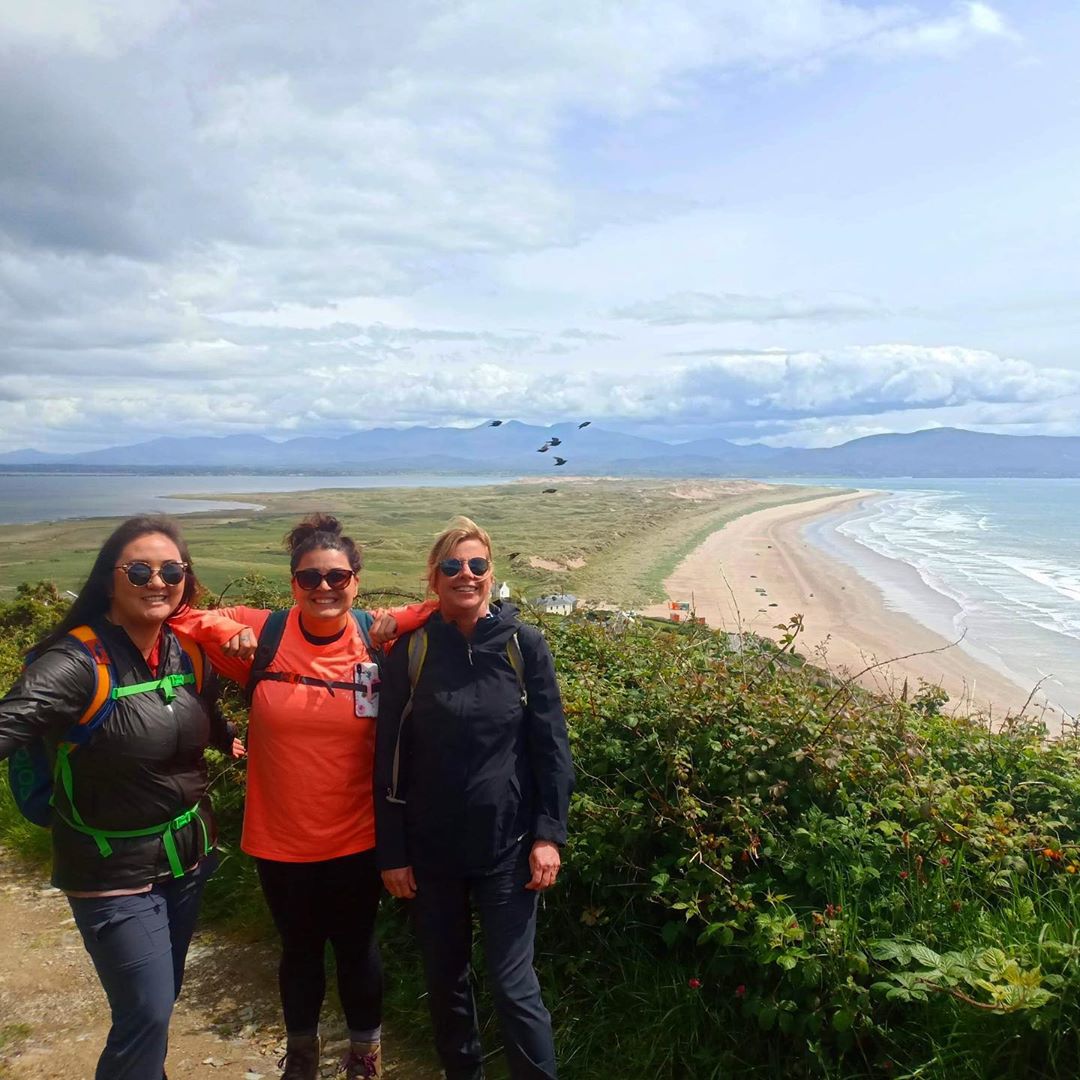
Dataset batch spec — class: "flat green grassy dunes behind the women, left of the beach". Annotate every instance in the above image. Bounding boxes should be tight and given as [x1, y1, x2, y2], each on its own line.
[0, 477, 835, 607]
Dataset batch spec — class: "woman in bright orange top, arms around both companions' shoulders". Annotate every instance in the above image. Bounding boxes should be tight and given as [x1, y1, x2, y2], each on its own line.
[170, 514, 435, 1080]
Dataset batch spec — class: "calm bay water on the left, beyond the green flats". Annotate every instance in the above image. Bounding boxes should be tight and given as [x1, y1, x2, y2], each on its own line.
[0, 472, 508, 525]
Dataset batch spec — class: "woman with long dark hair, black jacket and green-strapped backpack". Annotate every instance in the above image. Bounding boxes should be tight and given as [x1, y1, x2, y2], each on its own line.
[0, 517, 244, 1080]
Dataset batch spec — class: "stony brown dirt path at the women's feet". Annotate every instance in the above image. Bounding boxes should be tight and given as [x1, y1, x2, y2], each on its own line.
[0, 851, 440, 1080]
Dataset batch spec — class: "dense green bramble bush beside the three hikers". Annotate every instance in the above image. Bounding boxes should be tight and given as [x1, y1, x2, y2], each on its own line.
[6, 580, 1080, 1080]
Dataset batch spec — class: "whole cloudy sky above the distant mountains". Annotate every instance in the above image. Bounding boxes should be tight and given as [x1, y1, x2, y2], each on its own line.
[0, 0, 1080, 451]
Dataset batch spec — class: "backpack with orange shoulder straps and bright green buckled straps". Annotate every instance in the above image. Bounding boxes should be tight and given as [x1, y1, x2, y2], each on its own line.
[8, 626, 205, 838]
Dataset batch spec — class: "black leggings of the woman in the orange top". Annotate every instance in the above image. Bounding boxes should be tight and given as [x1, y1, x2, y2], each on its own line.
[255, 850, 382, 1035]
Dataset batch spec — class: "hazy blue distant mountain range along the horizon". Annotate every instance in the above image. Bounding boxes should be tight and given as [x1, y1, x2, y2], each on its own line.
[0, 420, 1080, 477]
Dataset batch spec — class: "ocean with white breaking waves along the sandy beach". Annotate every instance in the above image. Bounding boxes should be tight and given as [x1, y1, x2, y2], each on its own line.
[785, 478, 1080, 716]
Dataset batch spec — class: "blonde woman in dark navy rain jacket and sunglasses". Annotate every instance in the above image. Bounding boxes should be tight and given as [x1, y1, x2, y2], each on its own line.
[375, 518, 573, 1080]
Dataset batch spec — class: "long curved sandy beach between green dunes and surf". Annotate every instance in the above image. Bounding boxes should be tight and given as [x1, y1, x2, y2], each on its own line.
[648, 492, 1030, 718]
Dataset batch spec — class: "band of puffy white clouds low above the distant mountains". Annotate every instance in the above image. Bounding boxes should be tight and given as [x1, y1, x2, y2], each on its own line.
[0, 341, 1080, 448]
